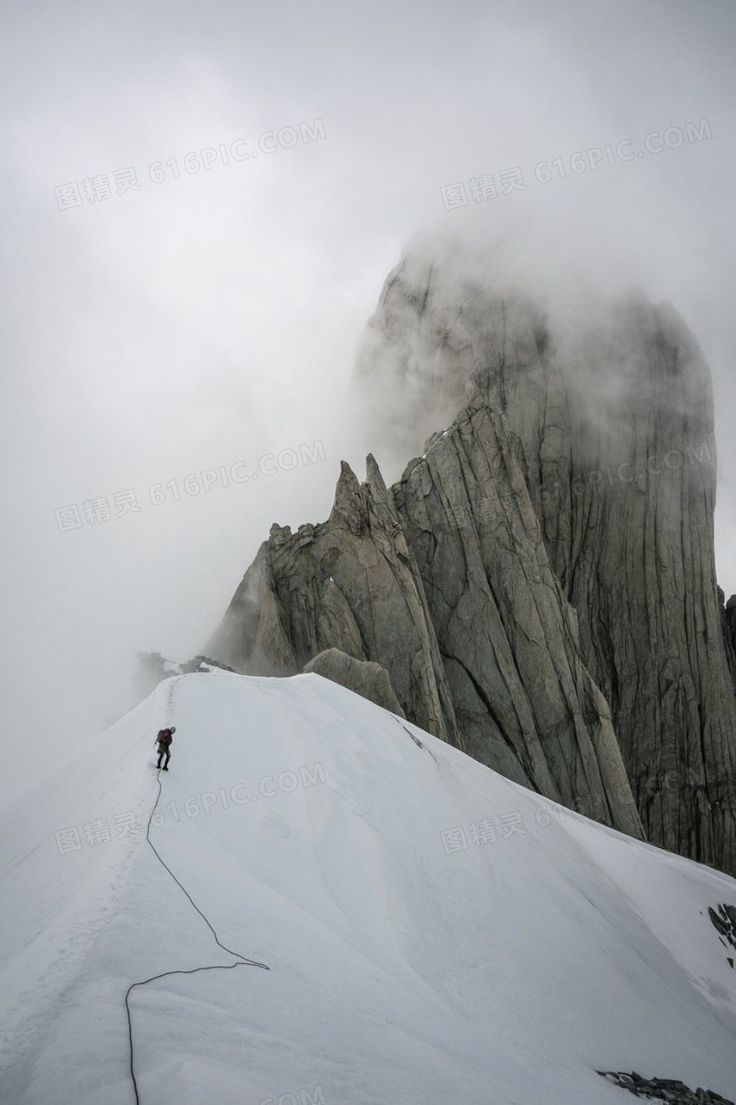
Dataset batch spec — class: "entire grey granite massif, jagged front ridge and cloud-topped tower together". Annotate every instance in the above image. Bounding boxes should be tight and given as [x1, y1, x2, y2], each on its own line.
[207, 248, 736, 872]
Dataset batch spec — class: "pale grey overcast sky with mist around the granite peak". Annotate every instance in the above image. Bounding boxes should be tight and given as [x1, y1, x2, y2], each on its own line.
[0, 0, 736, 793]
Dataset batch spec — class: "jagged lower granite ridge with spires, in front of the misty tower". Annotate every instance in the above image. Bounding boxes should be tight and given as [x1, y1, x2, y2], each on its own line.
[208, 442, 642, 836]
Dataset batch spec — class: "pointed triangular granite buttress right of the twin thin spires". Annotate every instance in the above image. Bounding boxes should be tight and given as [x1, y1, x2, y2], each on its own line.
[393, 403, 640, 834]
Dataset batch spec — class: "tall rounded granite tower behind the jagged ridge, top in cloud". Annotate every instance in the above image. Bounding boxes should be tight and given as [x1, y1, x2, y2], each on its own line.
[349, 256, 736, 872]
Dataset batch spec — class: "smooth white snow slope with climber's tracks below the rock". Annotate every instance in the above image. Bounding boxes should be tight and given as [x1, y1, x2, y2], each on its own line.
[0, 673, 736, 1105]
